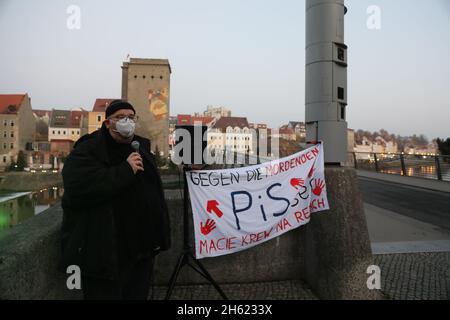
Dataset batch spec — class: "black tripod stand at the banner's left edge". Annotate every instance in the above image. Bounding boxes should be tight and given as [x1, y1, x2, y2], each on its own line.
[166, 164, 228, 300]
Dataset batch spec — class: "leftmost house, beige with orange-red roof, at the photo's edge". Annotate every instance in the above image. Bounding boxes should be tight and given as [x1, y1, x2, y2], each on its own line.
[0, 93, 36, 171]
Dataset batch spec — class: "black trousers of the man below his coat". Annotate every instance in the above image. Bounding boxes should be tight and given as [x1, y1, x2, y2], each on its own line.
[81, 257, 155, 300]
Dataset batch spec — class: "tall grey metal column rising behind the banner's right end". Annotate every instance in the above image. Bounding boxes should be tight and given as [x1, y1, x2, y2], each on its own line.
[305, 0, 347, 164]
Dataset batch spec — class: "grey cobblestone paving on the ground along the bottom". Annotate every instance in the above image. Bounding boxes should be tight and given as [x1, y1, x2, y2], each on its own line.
[154, 252, 450, 300]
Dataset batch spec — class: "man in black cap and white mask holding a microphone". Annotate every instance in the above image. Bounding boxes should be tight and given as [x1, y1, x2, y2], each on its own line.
[60, 100, 170, 300]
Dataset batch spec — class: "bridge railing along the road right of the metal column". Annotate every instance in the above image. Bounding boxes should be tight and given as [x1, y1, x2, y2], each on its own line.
[348, 152, 450, 181]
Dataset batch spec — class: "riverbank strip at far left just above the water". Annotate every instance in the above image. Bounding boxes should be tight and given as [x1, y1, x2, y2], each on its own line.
[0, 172, 63, 192]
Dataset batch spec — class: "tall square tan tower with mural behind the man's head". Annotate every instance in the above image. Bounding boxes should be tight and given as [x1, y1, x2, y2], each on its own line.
[122, 58, 172, 156]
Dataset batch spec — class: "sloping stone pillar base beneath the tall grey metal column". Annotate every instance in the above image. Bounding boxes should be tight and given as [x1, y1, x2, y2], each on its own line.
[300, 166, 381, 299]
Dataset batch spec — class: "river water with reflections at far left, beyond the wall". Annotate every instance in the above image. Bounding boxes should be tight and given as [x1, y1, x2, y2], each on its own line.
[0, 187, 64, 232]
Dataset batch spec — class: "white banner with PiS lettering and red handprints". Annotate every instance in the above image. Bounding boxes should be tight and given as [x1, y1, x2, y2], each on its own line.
[186, 144, 329, 259]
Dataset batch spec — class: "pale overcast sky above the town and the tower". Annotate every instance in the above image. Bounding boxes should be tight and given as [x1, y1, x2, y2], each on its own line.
[0, 0, 450, 138]
